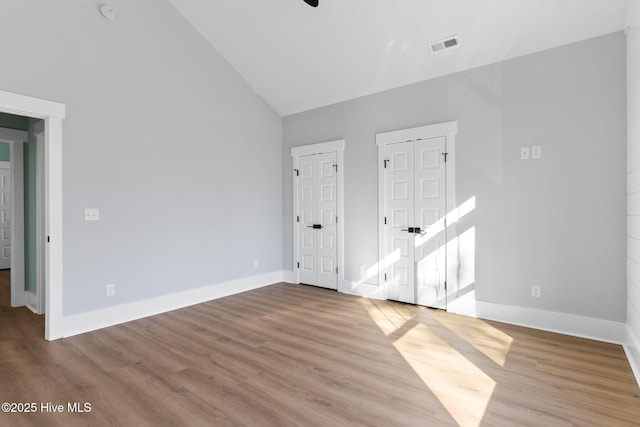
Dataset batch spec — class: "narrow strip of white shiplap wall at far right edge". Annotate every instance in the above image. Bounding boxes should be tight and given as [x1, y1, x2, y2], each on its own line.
[627, 2, 640, 372]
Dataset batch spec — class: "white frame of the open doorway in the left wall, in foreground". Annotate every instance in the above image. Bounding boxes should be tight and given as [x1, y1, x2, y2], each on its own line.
[0, 91, 66, 340]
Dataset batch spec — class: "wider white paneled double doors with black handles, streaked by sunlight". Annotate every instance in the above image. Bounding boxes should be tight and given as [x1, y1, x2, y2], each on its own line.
[384, 137, 446, 309]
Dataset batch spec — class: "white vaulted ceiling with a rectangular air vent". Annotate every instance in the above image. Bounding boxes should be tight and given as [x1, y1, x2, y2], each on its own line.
[169, 0, 637, 116]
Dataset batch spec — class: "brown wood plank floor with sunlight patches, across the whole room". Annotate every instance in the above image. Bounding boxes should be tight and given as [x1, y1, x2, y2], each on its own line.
[0, 272, 640, 427]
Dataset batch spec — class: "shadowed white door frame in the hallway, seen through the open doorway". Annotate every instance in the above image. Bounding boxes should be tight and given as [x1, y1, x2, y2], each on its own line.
[0, 128, 29, 307]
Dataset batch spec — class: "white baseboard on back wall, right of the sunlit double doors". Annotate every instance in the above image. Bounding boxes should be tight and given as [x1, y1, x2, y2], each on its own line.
[476, 301, 625, 344]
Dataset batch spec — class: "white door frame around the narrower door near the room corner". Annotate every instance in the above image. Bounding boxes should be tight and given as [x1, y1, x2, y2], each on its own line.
[291, 139, 345, 292]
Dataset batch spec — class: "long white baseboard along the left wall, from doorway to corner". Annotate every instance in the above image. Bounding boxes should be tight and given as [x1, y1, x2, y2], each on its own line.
[62, 271, 283, 338]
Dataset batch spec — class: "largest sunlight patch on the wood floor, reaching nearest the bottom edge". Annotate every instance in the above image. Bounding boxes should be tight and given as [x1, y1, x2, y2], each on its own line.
[394, 323, 496, 426]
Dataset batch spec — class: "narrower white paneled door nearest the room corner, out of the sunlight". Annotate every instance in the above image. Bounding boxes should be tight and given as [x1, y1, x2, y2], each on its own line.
[297, 152, 338, 289]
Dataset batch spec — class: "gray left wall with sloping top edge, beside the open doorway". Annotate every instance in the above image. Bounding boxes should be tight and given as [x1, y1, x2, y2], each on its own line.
[0, 0, 282, 315]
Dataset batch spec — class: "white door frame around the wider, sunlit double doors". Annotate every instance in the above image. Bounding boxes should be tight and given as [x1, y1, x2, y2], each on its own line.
[376, 121, 458, 304]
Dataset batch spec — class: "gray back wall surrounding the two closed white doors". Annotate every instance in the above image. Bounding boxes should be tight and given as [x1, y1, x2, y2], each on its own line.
[282, 33, 626, 322]
